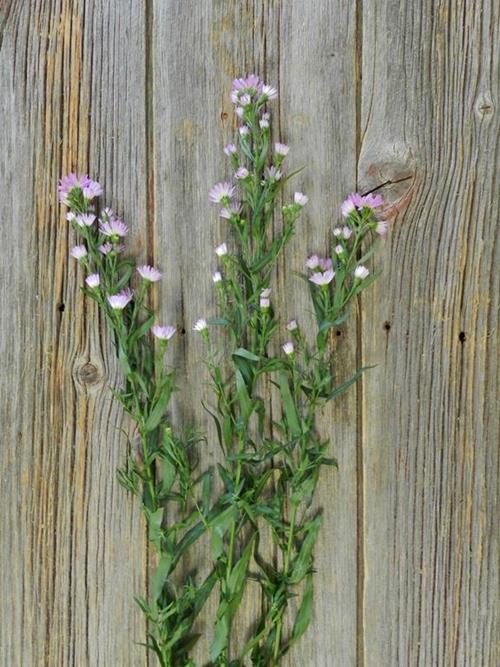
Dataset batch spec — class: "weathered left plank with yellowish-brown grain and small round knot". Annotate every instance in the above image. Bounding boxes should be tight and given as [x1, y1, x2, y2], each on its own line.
[0, 0, 147, 667]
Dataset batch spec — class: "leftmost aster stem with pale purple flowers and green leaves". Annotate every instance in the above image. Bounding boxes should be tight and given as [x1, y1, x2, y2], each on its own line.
[59, 174, 216, 667]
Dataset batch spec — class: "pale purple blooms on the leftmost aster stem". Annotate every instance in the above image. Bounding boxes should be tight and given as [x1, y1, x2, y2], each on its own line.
[58, 173, 176, 341]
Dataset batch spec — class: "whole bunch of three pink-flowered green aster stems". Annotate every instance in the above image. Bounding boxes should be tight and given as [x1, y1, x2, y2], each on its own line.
[60, 75, 388, 667]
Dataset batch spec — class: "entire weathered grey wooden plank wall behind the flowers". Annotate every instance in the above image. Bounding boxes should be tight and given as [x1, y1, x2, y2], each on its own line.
[0, 0, 500, 667]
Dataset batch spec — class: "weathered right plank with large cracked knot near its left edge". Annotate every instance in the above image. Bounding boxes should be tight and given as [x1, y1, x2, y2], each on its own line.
[360, 0, 500, 667]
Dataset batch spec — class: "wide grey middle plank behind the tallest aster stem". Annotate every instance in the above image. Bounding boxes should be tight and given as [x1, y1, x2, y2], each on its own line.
[152, 2, 357, 666]
